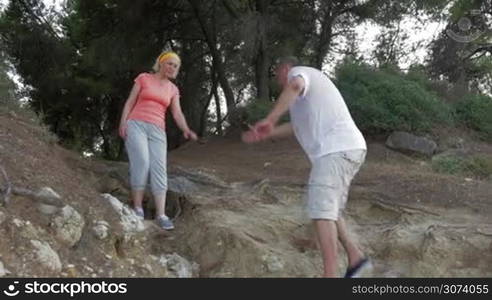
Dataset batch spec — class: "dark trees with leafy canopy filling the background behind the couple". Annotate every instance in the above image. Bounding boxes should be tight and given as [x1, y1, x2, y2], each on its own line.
[0, 0, 492, 159]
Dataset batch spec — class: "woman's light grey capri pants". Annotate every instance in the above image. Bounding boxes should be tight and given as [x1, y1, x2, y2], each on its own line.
[125, 120, 167, 196]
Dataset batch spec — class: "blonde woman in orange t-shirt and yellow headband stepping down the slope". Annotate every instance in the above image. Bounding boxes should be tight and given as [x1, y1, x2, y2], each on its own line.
[119, 51, 197, 230]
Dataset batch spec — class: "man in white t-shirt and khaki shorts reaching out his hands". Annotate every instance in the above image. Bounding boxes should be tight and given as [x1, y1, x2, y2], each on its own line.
[242, 57, 370, 277]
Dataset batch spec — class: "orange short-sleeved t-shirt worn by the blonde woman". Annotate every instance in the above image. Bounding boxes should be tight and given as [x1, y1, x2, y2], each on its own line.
[127, 73, 179, 129]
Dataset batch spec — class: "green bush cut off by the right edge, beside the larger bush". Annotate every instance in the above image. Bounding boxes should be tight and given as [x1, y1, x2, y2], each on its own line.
[456, 95, 492, 141]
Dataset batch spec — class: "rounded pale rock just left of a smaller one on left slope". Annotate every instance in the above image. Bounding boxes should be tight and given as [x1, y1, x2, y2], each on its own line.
[50, 205, 85, 247]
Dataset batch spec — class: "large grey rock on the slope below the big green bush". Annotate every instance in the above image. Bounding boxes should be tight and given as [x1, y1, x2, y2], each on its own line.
[386, 131, 437, 156]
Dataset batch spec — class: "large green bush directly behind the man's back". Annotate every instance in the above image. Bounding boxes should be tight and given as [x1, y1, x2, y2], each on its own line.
[336, 60, 454, 134]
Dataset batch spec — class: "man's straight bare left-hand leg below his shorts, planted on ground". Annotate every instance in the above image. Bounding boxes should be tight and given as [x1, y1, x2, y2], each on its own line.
[313, 219, 338, 277]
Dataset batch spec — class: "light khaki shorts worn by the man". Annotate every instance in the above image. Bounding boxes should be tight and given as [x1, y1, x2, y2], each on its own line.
[307, 150, 366, 221]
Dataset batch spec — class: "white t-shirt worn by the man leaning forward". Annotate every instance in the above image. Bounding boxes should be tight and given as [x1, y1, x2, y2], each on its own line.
[288, 67, 367, 162]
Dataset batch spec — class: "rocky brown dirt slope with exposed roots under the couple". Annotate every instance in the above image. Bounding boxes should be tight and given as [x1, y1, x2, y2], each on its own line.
[0, 112, 492, 277]
